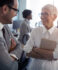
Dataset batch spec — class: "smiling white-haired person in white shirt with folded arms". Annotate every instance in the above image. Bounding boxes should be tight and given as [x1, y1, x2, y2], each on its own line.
[24, 4, 58, 70]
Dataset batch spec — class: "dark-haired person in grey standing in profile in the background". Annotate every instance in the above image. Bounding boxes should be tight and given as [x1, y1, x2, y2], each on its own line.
[19, 9, 32, 45]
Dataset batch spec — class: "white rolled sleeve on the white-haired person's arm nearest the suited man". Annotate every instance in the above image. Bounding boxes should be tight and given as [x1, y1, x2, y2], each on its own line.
[23, 30, 35, 53]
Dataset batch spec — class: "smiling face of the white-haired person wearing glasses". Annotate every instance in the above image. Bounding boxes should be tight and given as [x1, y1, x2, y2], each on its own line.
[41, 9, 54, 27]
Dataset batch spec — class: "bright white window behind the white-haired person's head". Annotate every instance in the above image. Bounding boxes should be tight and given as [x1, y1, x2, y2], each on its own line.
[26, 0, 58, 27]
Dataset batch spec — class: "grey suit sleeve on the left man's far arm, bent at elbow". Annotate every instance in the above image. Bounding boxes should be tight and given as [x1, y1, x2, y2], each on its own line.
[6, 27, 22, 59]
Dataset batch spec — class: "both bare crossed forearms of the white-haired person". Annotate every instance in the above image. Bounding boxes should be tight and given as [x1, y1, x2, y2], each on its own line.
[28, 48, 55, 60]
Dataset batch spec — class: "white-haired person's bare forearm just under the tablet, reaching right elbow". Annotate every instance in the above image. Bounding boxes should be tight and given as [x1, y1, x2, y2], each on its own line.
[33, 48, 55, 60]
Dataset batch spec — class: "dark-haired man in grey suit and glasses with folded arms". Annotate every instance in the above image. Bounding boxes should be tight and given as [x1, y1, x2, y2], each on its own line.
[0, 0, 22, 70]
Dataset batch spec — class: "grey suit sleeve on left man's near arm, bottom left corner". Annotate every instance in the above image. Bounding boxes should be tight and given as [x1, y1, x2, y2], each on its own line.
[0, 38, 18, 70]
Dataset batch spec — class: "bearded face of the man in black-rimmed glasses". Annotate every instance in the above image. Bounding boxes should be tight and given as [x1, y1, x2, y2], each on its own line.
[3, 0, 18, 24]
